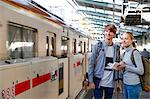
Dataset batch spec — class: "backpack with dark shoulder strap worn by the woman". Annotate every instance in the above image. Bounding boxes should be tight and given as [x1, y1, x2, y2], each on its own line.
[131, 49, 150, 92]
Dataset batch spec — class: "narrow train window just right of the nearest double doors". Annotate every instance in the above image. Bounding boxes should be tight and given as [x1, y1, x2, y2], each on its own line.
[61, 36, 68, 57]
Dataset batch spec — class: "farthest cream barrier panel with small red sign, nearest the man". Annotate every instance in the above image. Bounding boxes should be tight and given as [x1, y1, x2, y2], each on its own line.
[69, 54, 85, 99]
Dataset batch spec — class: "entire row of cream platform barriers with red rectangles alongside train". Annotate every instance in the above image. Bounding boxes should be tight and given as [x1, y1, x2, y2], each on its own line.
[0, 54, 86, 99]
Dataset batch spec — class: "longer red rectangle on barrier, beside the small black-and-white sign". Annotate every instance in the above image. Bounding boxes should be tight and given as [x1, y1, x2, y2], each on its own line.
[32, 73, 50, 87]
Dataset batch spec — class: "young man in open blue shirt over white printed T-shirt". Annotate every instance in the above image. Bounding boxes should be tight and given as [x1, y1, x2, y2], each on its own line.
[88, 24, 120, 99]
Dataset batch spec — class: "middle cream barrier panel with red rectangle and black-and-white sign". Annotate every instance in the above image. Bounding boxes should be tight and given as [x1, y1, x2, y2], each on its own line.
[29, 57, 58, 99]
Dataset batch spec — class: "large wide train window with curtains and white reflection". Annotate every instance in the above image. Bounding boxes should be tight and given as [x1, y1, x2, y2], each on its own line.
[8, 24, 36, 59]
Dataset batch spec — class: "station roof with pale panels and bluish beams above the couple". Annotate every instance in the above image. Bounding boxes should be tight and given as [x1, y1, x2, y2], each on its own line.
[74, 0, 150, 36]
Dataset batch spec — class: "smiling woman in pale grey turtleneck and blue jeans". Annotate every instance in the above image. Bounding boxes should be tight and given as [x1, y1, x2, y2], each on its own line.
[118, 32, 144, 99]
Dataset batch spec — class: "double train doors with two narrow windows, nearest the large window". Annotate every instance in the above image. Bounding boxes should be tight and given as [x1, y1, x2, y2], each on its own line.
[46, 32, 56, 56]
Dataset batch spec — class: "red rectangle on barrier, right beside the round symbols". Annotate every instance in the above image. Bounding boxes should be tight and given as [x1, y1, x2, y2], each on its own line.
[15, 80, 30, 96]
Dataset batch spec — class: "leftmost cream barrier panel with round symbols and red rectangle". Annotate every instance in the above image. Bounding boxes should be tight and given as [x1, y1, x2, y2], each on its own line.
[0, 62, 31, 99]
